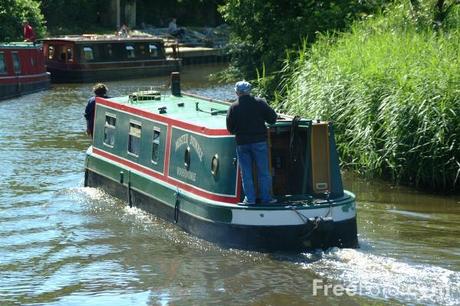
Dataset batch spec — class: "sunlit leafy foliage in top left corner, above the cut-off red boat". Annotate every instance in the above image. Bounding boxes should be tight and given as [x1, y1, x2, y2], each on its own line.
[0, 0, 46, 42]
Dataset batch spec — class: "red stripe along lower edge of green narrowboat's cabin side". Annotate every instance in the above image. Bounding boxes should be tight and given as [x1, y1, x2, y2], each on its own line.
[93, 147, 240, 204]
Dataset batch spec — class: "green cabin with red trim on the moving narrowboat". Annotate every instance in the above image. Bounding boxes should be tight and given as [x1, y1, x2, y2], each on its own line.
[88, 92, 343, 204]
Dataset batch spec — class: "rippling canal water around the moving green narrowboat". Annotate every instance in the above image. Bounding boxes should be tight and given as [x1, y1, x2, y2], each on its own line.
[0, 66, 460, 306]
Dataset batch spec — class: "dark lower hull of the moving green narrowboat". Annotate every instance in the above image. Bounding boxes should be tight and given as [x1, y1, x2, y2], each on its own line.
[85, 168, 358, 252]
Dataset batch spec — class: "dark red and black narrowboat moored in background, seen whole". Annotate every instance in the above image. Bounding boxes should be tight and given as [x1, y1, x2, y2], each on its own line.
[42, 34, 181, 83]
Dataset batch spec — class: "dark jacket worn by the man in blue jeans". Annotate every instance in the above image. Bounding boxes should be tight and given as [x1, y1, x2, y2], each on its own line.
[227, 95, 278, 145]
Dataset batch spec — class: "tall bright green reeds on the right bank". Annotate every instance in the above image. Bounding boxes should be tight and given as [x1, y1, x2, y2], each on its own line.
[278, 8, 460, 192]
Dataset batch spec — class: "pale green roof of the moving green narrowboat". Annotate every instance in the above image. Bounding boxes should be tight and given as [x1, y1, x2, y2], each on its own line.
[98, 91, 304, 131]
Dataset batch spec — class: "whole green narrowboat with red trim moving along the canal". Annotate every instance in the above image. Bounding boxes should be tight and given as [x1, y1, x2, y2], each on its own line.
[85, 76, 358, 251]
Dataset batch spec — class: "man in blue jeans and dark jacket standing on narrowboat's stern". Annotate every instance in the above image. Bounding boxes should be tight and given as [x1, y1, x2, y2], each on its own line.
[227, 81, 278, 205]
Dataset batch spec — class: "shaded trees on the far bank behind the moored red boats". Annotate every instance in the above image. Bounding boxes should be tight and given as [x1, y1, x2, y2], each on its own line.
[0, 0, 224, 41]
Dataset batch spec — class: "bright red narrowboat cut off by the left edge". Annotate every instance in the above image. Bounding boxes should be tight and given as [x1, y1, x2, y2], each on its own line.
[0, 42, 50, 100]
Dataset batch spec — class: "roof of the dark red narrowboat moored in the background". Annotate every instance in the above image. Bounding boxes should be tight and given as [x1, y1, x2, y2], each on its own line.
[41, 34, 163, 43]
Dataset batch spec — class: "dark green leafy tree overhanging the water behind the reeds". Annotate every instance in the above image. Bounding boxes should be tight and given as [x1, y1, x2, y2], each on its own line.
[219, 0, 388, 79]
